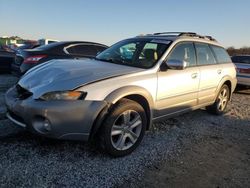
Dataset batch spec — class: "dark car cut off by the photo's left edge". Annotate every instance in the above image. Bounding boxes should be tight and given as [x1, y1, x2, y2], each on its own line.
[0, 46, 15, 73]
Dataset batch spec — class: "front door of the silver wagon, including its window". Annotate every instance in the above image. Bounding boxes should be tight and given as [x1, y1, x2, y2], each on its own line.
[156, 42, 200, 116]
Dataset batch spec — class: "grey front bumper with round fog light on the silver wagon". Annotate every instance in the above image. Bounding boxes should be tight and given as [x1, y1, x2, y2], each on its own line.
[5, 87, 107, 141]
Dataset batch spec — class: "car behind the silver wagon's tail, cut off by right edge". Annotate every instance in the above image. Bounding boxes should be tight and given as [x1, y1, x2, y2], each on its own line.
[231, 55, 250, 86]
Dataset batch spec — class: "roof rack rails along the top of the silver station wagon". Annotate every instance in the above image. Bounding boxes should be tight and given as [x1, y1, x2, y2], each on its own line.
[139, 32, 216, 41]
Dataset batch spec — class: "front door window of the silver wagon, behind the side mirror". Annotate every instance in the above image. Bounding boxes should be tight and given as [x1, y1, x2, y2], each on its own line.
[168, 42, 196, 67]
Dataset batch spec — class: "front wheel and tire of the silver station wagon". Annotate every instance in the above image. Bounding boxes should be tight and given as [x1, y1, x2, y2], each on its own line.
[98, 99, 147, 157]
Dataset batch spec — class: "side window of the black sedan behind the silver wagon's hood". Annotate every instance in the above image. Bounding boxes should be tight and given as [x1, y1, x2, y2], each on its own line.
[67, 45, 97, 56]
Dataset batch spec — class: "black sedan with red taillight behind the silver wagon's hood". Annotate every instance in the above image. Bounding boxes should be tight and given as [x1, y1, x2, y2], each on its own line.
[12, 41, 107, 76]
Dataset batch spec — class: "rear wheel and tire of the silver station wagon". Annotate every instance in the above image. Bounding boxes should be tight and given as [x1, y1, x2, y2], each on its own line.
[206, 84, 230, 115]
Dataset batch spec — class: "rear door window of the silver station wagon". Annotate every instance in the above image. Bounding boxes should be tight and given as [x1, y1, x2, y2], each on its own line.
[195, 43, 216, 65]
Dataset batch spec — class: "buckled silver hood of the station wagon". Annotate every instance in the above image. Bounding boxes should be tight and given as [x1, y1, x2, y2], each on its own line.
[18, 59, 143, 98]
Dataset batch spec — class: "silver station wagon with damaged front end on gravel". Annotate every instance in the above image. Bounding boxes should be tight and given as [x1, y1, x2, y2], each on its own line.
[5, 32, 237, 157]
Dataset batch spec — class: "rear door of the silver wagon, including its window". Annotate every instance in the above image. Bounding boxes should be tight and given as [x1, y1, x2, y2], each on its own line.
[195, 43, 223, 104]
